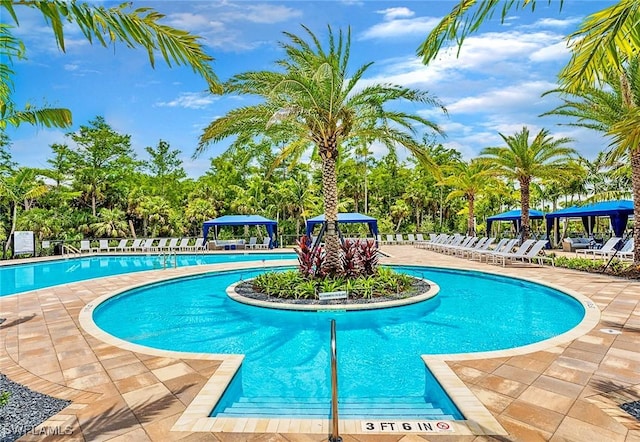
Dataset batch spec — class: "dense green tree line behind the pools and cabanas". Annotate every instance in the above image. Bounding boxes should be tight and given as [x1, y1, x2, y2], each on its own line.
[0, 116, 631, 252]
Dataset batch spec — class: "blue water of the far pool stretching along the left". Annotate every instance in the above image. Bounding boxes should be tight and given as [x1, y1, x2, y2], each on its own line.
[0, 253, 296, 296]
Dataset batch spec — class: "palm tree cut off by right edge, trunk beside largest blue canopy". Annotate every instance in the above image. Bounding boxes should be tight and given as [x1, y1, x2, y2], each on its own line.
[545, 55, 640, 265]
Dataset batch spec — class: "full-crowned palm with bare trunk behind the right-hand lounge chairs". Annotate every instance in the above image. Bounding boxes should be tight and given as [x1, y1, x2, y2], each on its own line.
[481, 127, 576, 240]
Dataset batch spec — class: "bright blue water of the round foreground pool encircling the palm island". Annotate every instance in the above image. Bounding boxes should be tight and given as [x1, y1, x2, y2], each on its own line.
[94, 267, 584, 419]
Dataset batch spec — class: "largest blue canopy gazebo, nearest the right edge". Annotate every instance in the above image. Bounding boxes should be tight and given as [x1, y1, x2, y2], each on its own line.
[546, 200, 633, 242]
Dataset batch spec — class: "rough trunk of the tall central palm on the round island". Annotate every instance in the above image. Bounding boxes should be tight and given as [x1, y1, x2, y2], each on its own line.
[322, 154, 342, 275]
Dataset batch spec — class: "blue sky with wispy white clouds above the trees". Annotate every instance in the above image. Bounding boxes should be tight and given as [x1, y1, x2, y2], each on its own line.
[5, 0, 613, 178]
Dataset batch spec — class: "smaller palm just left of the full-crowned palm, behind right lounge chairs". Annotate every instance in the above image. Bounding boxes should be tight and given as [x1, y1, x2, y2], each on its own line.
[442, 158, 494, 236]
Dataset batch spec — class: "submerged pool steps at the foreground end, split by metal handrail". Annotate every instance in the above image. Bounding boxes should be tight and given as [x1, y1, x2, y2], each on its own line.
[216, 397, 455, 420]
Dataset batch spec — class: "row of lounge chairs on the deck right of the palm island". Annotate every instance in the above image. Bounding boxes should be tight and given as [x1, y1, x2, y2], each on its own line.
[415, 234, 553, 266]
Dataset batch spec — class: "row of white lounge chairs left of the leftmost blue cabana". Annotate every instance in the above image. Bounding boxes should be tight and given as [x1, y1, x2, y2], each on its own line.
[79, 238, 206, 253]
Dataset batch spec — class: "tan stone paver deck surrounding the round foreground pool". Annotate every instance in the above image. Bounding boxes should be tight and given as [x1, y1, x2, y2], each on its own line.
[0, 246, 640, 442]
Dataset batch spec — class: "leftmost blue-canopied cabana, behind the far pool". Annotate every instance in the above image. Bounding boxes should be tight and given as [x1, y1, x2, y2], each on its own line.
[202, 215, 278, 250]
